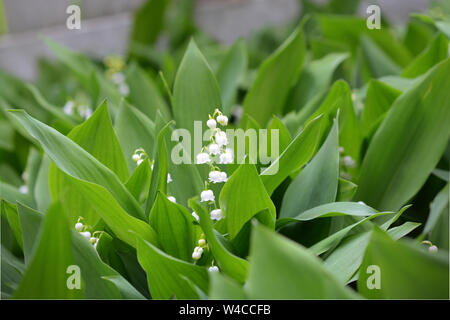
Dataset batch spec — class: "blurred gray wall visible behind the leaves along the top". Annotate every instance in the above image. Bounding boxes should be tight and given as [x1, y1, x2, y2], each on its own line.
[0, 0, 430, 79]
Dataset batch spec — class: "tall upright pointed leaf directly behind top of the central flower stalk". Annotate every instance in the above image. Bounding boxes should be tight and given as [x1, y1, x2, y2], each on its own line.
[173, 41, 222, 134]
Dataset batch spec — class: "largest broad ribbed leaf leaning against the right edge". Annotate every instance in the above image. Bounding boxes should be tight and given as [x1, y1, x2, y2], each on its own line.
[355, 59, 450, 210]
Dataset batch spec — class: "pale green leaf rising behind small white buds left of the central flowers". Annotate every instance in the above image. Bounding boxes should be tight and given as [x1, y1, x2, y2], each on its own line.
[114, 102, 156, 172]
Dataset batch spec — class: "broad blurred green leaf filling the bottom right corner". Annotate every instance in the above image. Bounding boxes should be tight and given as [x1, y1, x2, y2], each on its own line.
[358, 229, 449, 299]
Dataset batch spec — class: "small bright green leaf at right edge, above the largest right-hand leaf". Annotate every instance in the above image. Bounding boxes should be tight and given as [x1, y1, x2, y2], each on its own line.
[402, 33, 449, 78]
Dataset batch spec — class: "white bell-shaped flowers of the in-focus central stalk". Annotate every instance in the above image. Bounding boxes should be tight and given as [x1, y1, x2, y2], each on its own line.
[192, 109, 234, 264]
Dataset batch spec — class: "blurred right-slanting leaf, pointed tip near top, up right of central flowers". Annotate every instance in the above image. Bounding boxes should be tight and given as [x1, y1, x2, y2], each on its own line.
[243, 23, 306, 126]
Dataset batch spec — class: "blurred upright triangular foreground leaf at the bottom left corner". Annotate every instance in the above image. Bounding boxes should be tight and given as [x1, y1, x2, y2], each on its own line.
[14, 203, 83, 299]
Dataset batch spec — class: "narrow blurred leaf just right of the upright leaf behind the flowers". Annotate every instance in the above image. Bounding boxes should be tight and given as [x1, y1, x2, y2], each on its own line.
[217, 40, 247, 114]
